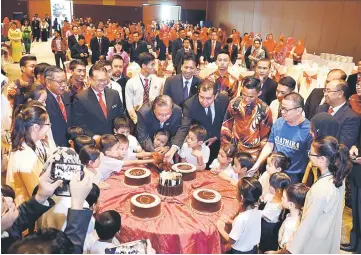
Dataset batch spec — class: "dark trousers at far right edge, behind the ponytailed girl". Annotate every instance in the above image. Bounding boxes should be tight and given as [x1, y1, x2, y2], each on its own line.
[349, 164, 361, 254]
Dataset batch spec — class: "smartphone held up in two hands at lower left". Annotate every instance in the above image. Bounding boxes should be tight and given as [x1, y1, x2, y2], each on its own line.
[50, 163, 84, 197]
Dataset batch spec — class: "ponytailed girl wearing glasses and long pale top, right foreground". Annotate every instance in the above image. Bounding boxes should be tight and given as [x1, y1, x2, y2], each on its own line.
[287, 136, 352, 254]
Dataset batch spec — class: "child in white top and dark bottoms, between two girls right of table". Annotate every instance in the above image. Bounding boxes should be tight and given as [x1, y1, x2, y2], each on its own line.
[259, 173, 291, 252]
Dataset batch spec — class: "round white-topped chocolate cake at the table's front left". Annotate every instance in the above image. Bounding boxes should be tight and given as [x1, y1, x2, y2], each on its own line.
[130, 193, 161, 219]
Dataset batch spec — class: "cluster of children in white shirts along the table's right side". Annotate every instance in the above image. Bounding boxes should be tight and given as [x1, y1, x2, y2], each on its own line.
[211, 149, 309, 254]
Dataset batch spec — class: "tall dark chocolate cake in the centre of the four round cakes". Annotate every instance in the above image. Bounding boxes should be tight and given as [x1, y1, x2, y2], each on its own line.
[157, 171, 183, 197]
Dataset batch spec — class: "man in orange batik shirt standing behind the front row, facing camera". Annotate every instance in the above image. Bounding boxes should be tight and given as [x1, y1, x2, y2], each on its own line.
[208, 50, 238, 99]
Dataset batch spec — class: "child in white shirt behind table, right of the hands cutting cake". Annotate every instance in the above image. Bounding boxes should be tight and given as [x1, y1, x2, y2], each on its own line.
[178, 125, 210, 171]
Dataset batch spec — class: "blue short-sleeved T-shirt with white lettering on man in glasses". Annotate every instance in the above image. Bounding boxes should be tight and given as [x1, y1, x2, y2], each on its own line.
[268, 118, 312, 174]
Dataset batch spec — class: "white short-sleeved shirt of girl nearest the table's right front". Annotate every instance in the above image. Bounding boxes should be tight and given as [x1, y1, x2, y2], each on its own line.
[229, 208, 262, 252]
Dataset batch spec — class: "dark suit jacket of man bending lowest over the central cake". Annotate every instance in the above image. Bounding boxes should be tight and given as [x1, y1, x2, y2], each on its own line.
[137, 103, 186, 151]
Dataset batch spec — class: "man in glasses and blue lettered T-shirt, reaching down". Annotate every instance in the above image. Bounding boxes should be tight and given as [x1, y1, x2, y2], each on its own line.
[248, 92, 312, 183]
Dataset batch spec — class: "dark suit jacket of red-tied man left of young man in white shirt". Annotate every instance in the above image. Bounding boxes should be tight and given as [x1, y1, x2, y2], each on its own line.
[73, 88, 124, 137]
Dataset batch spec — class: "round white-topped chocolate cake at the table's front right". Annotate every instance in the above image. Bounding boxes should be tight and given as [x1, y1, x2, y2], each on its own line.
[192, 189, 222, 212]
